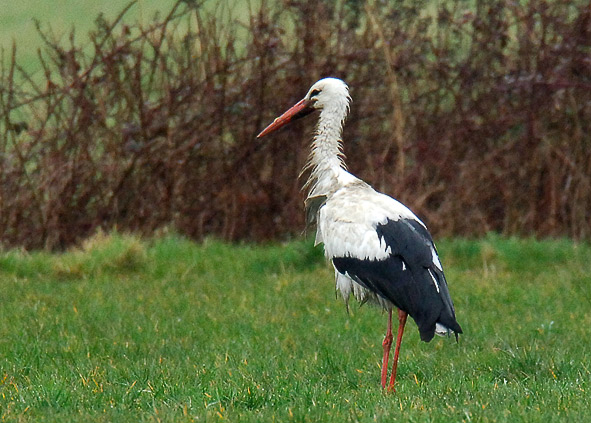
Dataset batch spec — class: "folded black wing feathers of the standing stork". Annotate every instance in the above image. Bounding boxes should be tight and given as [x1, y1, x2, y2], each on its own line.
[332, 218, 462, 342]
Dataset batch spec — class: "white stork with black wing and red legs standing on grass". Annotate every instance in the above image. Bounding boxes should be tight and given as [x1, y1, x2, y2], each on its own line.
[257, 78, 462, 390]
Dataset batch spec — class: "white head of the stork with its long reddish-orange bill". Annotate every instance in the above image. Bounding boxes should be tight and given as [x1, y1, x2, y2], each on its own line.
[257, 78, 351, 138]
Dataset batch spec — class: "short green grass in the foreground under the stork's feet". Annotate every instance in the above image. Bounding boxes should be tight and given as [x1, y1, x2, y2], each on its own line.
[0, 234, 591, 422]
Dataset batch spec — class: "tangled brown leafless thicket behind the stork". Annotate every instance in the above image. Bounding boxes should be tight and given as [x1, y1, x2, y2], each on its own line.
[0, 0, 591, 249]
